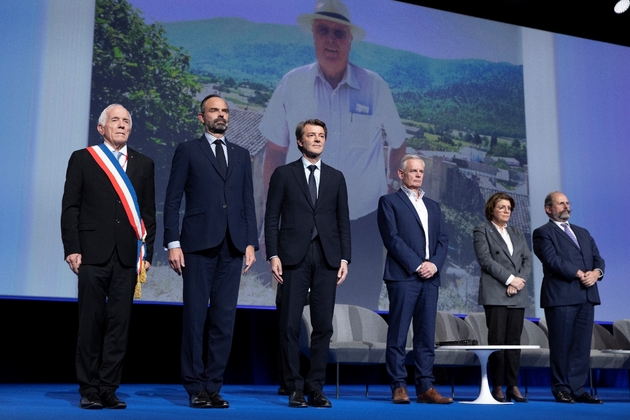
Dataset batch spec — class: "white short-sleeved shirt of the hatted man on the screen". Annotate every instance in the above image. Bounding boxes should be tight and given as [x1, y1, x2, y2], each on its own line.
[258, 63, 406, 220]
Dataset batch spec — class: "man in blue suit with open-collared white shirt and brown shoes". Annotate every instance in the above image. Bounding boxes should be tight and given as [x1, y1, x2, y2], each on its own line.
[378, 155, 453, 404]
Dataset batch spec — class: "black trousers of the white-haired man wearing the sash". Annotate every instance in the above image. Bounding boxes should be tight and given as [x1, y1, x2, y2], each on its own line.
[75, 250, 137, 396]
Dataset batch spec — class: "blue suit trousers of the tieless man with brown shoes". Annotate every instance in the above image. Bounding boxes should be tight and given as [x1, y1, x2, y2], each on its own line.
[385, 279, 439, 395]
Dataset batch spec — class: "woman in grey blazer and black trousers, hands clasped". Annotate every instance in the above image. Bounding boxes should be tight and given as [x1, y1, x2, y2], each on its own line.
[473, 193, 532, 402]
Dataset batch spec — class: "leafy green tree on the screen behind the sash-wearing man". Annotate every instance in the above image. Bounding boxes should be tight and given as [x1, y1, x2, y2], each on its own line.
[89, 0, 201, 262]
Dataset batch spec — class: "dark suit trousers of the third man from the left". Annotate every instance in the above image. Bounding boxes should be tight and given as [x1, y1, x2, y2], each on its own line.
[280, 238, 339, 393]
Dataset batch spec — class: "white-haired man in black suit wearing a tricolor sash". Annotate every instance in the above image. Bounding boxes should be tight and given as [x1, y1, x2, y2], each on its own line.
[61, 104, 155, 409]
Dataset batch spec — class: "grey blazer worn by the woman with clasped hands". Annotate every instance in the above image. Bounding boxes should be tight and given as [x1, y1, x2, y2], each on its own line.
[473, 222, 532, 308]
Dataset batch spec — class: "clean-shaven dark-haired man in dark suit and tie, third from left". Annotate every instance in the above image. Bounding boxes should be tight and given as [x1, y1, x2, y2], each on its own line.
[265, 119, 350, 407]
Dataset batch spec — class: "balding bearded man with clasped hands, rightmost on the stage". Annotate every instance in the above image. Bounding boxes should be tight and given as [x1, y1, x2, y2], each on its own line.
[533, 191, 605, 404]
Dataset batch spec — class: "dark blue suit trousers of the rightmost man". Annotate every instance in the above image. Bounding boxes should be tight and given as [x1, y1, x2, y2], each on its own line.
[545, 301, 595, 397]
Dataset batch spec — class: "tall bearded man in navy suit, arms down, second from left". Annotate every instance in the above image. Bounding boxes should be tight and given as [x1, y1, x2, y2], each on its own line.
[164, 95, 258, 408]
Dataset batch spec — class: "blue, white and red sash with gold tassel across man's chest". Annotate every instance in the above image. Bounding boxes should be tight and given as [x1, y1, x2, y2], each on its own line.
[87, 143, 147, 299]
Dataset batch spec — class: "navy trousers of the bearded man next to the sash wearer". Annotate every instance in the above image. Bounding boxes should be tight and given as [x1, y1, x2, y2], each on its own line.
[181, 235, 243, 395]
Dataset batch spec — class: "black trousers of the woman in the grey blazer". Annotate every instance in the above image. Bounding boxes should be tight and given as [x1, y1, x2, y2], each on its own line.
[483, 305, 525, 386]
